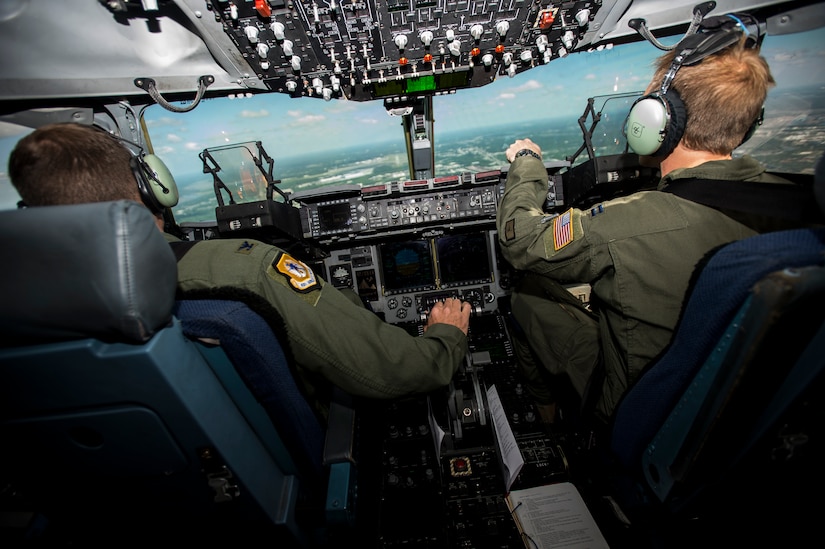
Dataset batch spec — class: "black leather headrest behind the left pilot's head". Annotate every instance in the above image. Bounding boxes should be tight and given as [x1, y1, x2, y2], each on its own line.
[0, 200, 177, 345]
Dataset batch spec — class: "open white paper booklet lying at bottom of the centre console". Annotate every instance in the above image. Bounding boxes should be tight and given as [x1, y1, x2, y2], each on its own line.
[506, 482, 609, 549]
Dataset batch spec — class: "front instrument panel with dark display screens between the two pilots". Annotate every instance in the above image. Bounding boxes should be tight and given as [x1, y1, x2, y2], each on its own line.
[292, 163, 566, 324]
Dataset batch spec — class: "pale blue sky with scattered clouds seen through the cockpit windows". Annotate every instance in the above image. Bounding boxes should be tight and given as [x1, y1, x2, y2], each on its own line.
[0, 24, 825, 209]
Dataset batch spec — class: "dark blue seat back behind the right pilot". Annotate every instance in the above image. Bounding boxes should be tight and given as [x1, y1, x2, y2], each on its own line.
[611, 229, 825, 532]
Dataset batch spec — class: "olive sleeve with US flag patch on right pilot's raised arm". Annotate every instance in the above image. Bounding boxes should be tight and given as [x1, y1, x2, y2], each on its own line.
[496, 156, 593, 282]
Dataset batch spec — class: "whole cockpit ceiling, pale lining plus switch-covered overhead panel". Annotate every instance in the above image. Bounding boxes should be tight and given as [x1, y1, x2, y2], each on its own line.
[0, 0, 825, 101]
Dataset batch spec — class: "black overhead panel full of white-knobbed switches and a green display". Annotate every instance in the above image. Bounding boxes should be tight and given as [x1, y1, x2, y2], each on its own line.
[209, 0, 602, 101]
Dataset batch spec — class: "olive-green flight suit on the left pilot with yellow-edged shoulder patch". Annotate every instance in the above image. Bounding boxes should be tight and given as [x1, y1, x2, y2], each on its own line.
[166, 234, 468, 413]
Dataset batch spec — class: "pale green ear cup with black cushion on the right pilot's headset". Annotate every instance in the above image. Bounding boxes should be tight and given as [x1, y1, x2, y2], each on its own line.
[624, 90, 687, 157]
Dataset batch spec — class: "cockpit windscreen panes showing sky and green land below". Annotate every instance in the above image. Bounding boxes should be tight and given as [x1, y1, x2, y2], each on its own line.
[0, 28, 825, 218]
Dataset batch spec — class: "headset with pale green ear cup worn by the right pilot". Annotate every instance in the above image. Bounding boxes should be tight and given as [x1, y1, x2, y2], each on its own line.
[623, 14, 765, 157]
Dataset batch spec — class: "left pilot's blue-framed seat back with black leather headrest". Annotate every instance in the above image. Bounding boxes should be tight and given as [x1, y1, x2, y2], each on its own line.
[0, 201, 310, 546]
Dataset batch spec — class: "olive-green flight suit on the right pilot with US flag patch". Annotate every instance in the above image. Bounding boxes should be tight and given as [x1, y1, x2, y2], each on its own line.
[496, 156, 787, 419]
